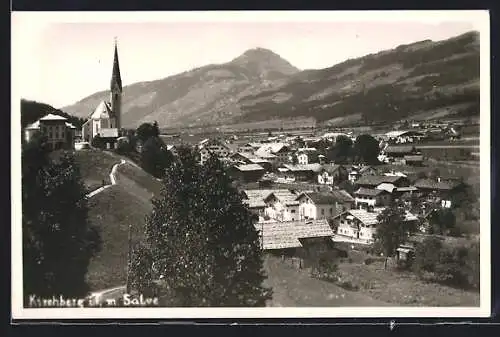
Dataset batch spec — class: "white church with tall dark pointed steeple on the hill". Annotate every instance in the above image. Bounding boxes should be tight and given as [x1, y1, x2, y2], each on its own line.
[82, 40, 123, 149]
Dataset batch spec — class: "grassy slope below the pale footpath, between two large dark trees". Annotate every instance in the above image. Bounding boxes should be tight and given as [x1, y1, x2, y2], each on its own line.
[87, 156, 160, 290]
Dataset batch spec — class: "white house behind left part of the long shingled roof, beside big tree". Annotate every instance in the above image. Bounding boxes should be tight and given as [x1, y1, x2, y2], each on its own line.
[264, 190, 299, 221]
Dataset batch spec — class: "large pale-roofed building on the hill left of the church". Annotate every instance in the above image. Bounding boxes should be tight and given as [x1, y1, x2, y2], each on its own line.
[24, 114, 76, 150]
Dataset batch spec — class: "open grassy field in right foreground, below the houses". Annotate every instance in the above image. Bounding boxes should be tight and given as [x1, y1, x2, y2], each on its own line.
[264, 245, 479, 307]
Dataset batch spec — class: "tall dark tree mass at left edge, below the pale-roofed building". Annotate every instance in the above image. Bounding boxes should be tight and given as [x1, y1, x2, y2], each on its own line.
[22, 138, 101, 298]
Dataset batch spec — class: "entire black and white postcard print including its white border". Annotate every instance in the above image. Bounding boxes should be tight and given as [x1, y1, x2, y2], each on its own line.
[11, 10, 491, 319]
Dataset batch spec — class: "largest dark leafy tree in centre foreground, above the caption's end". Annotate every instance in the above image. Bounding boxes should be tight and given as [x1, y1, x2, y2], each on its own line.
[131, 148, 271, 306]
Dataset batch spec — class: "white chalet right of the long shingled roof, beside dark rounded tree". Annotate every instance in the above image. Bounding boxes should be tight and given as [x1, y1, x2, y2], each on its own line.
[333, 207, 418, 244]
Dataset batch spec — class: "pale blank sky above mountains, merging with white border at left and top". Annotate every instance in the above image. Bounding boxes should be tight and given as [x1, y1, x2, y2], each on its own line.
[12, 12, 478, 108]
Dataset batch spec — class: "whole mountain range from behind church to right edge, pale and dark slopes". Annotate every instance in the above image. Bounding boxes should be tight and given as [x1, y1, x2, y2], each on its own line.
[62, 32, 479, 127]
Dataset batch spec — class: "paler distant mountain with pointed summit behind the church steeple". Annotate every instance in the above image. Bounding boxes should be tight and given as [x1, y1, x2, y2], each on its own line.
[63, 48, 298, 127]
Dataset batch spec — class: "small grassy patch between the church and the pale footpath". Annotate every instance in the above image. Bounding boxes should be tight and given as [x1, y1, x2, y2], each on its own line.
[75, 149, 120, 191]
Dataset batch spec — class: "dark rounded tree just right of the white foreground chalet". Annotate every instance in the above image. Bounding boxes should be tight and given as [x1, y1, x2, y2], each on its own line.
[374, 204, 417, 268]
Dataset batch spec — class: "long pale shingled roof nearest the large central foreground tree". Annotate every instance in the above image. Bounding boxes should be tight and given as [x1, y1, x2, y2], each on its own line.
[255, 219, 334, 250]
